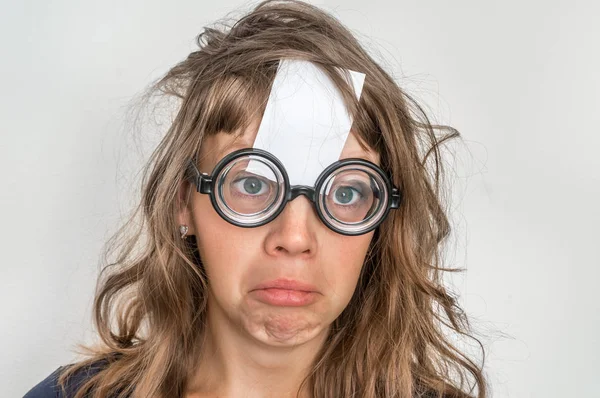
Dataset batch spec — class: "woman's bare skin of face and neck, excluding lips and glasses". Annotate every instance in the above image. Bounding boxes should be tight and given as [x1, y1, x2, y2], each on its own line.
[178, 119, 379, 398]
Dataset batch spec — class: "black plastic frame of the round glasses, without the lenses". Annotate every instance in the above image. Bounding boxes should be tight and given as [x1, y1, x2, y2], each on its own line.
[188, 148, 402, 236]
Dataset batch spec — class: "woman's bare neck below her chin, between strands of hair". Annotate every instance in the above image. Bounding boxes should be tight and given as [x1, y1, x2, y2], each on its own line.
[188, 300, 327, 397]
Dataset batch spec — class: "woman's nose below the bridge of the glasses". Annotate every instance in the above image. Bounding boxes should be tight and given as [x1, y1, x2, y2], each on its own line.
[264, 195, 320, 257]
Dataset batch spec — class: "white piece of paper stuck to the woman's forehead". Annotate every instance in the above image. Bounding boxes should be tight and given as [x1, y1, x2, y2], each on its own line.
[248, 59, 365, 186]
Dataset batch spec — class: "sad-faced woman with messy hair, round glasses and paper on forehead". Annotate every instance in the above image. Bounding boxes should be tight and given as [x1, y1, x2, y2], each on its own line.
[26, 1, 486, 398]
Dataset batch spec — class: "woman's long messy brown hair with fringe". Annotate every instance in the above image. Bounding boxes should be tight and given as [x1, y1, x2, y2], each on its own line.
[60, 1, 486, 398]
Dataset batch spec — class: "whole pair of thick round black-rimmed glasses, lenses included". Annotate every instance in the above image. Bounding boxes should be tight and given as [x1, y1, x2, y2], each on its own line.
[189, 148, 401, 235]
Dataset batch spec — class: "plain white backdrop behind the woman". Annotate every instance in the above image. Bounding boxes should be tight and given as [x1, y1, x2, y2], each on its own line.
[0, 0, 600, 398]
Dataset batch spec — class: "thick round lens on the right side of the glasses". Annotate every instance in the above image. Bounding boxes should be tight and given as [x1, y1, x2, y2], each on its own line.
[319, 165, 387, 233]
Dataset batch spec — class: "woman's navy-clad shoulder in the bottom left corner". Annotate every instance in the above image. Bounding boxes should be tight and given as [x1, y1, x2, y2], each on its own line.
[23, 361, 106, 398]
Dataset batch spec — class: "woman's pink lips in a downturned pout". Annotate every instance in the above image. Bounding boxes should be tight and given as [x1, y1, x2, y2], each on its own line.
[250, 279, 320, 307]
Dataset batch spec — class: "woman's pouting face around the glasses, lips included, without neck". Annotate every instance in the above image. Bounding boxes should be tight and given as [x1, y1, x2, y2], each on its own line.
[180, 124, 379, 346]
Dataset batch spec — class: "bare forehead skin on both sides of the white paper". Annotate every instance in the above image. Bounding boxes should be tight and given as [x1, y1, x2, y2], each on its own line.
[199, 121, 380, 172]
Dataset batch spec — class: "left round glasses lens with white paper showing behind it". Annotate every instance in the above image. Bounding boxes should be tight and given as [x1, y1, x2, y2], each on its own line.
[217, 155, 285, 224]
